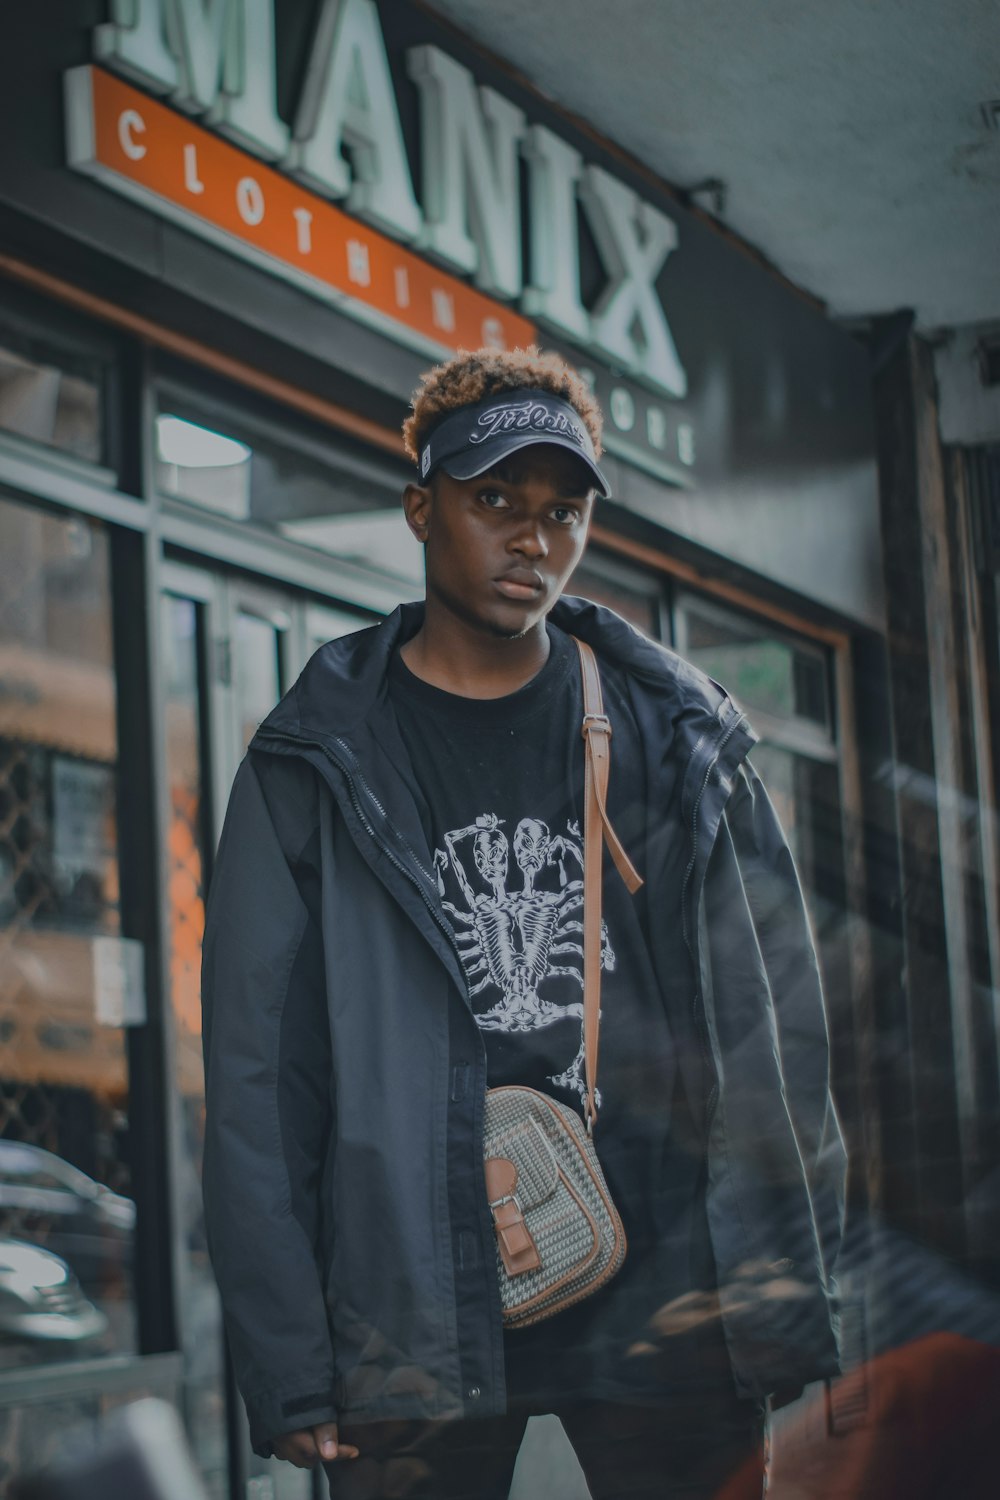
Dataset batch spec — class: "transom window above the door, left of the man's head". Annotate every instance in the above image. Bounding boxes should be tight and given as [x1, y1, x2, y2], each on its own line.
[154, 372, 423, 599]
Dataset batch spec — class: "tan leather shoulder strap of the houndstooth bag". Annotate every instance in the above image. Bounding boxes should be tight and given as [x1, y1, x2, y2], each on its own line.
[576, 641, 642, 1131]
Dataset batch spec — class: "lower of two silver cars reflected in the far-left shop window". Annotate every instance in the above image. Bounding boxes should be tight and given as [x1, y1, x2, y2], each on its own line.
[0, 1235, 108, 1343]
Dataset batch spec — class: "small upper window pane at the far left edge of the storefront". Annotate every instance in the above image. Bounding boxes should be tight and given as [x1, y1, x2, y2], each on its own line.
[0, 343, 102, 464]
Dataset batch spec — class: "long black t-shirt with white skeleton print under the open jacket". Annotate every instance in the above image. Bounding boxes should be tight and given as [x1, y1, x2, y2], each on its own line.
[390, 626, 730, 1404]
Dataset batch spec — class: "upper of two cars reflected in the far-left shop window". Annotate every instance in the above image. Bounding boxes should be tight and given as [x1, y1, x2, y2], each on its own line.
[0, 1140, 135, 1290]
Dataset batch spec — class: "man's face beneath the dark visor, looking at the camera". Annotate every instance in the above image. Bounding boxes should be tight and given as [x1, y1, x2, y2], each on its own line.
[403, 443, 594, 639]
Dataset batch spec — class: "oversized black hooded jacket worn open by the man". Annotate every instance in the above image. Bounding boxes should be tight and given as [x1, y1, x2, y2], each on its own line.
[204, 599, 844, 1454]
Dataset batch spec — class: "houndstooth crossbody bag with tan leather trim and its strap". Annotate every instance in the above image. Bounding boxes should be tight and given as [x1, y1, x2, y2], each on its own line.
[484, 641, 642, 1328]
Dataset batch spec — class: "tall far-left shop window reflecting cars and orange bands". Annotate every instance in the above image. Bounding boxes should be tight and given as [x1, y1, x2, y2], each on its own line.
[0, 498, 135, 1382]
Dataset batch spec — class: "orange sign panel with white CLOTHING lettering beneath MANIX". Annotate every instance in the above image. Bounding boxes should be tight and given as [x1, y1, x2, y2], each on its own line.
[66, 68, 535, 363]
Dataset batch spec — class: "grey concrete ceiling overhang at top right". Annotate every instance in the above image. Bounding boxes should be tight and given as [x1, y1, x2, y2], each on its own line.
[433, 0, 1000, 332]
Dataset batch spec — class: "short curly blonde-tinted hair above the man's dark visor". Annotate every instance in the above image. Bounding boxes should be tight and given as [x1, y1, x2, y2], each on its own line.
[403, 344, 604, 464]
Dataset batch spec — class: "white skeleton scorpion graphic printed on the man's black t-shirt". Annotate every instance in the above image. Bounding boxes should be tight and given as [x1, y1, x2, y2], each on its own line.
[433, 813, 615, 1103]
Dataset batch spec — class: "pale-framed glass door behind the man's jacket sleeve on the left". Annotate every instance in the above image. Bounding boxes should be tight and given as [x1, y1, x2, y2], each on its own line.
[159, 563, 364, 1500]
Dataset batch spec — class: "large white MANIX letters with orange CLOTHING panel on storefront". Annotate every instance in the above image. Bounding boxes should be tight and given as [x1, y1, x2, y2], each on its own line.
[69, 0, 688, 399]
